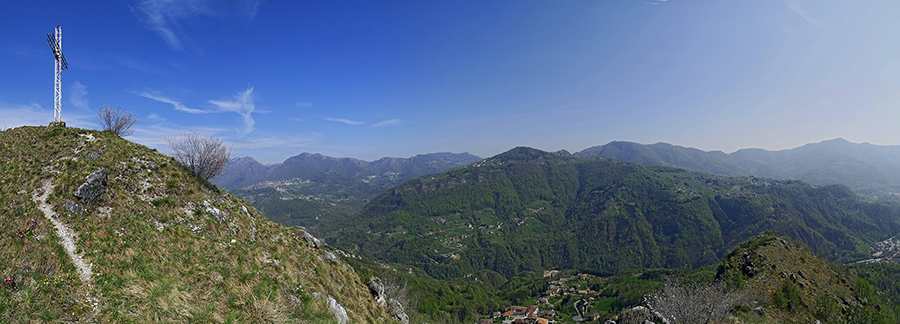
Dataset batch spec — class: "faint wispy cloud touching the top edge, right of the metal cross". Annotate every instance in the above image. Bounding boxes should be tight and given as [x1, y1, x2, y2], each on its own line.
[132, 0, 259, 50]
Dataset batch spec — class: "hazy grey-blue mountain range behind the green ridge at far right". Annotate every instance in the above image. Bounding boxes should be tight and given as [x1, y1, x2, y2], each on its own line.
[575, 138, 900, 195]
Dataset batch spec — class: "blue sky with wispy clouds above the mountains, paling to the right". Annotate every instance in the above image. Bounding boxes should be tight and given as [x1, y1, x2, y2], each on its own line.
[0, 0, 900, 163]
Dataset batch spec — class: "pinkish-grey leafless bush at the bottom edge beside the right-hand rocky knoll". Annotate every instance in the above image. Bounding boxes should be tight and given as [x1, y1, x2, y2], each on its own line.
[646, 279, 746, 324]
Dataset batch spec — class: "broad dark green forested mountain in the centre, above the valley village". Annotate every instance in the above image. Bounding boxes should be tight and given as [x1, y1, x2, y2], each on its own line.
[331, 148, 900, 278]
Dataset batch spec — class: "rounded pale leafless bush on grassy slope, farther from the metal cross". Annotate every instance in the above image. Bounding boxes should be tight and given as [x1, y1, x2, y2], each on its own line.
[165, 130, 231, 180]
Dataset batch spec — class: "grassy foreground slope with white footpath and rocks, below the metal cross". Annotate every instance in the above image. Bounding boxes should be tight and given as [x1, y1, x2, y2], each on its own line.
[0, 127, 391, 323]
